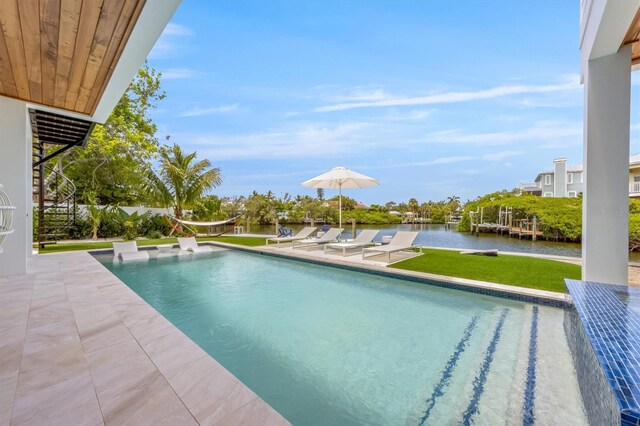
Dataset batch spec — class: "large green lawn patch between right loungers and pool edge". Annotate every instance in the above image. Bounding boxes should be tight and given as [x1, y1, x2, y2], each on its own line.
[391, 250, 580, 293]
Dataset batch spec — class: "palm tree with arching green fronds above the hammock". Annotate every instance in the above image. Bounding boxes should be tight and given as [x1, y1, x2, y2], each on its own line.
[145, 144, 222, 219]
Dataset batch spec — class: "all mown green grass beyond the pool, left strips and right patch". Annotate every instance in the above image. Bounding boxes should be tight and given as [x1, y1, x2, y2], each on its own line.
[40, 236, 580, 293]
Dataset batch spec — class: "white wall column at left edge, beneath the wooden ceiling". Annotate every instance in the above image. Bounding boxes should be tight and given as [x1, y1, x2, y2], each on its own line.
[0, 97, 33, 276]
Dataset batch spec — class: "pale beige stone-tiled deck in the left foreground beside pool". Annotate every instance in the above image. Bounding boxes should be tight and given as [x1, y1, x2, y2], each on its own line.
[0, 252, 288, 425]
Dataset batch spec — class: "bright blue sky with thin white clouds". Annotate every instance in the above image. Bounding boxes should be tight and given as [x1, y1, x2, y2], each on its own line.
[149, 0, 640, 204]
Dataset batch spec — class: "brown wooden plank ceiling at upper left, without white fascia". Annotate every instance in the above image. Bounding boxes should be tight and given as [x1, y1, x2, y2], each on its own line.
[0, 0, 145, 115]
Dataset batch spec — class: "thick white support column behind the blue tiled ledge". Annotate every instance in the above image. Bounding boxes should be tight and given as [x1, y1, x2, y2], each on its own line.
[582, 47, 631, 285]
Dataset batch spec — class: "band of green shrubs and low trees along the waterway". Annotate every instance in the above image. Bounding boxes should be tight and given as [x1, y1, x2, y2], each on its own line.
[51, 190, 640, 251]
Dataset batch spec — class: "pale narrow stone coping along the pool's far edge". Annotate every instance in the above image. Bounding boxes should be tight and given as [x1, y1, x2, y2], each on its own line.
[82, 241, 573, 308]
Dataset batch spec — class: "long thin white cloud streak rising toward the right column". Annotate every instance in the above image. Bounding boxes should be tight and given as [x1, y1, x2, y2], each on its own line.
[314, 78, 580, 112]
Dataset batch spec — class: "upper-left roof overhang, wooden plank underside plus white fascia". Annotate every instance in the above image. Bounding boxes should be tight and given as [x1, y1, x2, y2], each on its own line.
[0, 0, 180, 123]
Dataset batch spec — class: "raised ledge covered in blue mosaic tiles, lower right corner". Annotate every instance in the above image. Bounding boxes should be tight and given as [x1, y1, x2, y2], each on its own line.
[565, 280, 640, 426]
